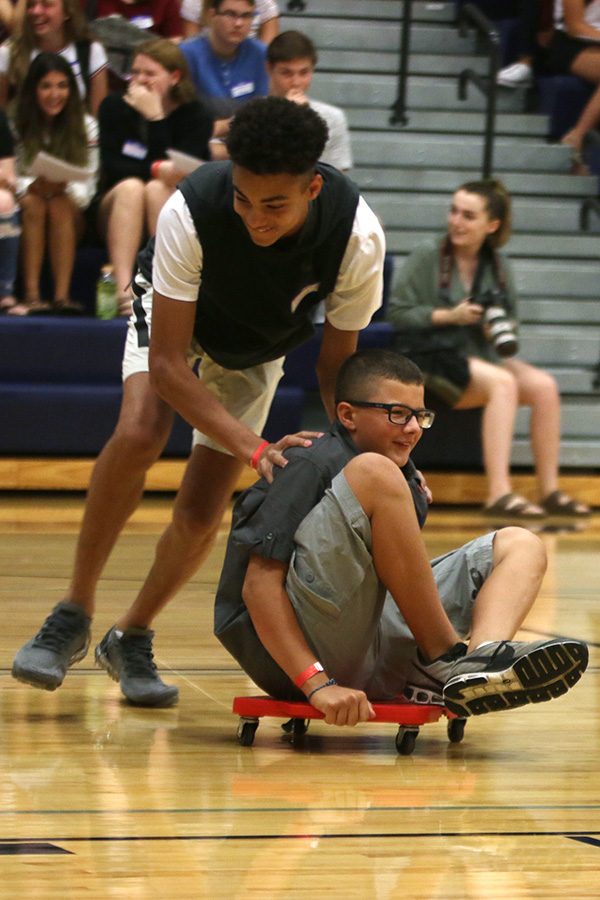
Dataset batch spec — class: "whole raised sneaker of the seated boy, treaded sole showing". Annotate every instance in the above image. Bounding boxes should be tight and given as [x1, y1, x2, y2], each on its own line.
[444, 638, 588, 717]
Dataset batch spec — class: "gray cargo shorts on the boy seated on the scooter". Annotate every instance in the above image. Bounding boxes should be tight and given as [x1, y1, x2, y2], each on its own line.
[287, 472, 495, 699]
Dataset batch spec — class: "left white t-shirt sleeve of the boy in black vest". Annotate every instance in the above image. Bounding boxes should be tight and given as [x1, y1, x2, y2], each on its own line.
[152, 191, 202, 303]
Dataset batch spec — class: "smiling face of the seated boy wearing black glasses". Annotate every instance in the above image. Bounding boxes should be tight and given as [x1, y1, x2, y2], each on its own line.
[337, 378, 425, 466]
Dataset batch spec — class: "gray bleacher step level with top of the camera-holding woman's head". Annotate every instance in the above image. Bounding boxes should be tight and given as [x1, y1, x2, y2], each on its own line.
[352, 169, 597, 198]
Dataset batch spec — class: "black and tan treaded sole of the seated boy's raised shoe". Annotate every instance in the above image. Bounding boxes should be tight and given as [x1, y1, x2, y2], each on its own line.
[444, 641, 589, 718]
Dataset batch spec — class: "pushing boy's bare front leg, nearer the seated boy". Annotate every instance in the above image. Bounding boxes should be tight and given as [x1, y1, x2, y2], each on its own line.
[117, 446, 243, 630]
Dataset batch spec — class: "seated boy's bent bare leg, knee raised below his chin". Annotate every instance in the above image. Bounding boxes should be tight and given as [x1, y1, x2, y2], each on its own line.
[344, 453, 460, 659]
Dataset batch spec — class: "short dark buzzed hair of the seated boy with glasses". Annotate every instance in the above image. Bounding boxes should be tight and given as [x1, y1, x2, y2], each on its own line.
[335, 348, 423, 405]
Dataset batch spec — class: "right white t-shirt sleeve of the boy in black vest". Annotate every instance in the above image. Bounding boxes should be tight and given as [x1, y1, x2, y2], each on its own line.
[325, 197, 385, 331]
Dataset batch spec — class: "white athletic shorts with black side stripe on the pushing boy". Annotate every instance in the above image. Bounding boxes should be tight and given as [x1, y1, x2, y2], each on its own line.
[122, 273, 284, 456]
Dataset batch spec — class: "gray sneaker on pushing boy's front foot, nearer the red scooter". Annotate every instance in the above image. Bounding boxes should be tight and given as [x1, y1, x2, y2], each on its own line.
[95, 628, 179, 706]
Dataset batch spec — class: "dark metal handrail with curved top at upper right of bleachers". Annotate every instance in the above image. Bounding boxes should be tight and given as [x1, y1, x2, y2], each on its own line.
[457, 3, 500, 178]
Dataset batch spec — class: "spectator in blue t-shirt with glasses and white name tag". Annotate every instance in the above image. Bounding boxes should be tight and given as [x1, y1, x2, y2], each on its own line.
[181, 0, 269, 118]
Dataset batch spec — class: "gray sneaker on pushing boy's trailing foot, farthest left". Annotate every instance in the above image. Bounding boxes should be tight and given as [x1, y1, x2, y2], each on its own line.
[12, 600, 92, 691]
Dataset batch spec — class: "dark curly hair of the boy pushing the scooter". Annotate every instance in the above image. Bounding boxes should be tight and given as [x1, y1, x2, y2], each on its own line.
[226, 97, 328, 175]
